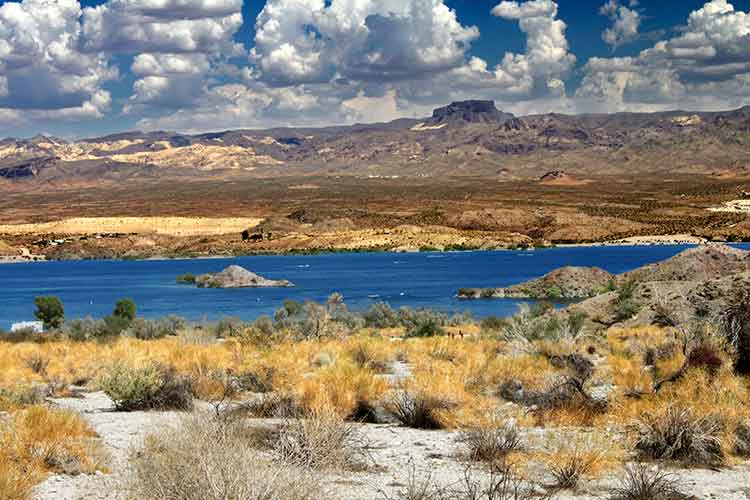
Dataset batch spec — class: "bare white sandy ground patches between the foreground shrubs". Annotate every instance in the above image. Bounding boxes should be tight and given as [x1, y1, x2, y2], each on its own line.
[34, 392, 750, 500]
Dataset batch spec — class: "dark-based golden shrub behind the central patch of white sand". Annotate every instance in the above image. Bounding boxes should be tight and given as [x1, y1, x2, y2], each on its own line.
[386, 388, 455, 429]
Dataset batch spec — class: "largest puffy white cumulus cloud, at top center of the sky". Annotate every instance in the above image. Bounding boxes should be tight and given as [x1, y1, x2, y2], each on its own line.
[252, 0, 479, 86]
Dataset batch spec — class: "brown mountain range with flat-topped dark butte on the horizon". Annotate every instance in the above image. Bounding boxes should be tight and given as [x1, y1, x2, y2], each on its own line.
[0, 101, 750, 183]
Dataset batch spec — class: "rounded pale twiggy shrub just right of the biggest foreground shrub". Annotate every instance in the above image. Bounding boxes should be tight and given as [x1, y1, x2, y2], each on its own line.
[270, 410, 367, 470]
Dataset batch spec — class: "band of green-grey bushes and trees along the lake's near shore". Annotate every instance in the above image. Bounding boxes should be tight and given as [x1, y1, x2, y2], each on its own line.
[0, 292, 488, 341]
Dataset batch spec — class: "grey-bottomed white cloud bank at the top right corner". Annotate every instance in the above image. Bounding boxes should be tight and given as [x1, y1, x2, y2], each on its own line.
[577, 0, 750, 111]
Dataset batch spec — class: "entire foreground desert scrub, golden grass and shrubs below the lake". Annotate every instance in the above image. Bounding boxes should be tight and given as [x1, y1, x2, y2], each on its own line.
[0, 289, 750, 500]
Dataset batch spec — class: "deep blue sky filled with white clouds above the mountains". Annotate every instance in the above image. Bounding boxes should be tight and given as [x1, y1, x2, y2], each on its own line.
[0, 0, 750, 138]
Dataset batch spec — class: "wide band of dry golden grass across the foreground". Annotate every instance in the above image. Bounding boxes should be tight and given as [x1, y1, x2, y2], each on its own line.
[0, 320, 750, 496]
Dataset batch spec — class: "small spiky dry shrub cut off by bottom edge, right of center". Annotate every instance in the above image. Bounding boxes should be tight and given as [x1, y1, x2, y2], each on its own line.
[607, 464, 689, 500]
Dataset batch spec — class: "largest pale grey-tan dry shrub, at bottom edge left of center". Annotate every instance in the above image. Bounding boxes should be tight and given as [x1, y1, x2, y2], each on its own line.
[127, 416, 327, 500]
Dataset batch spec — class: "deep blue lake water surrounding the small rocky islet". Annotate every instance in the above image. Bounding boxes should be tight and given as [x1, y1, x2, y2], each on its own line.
[0, 245, 740, 329]
